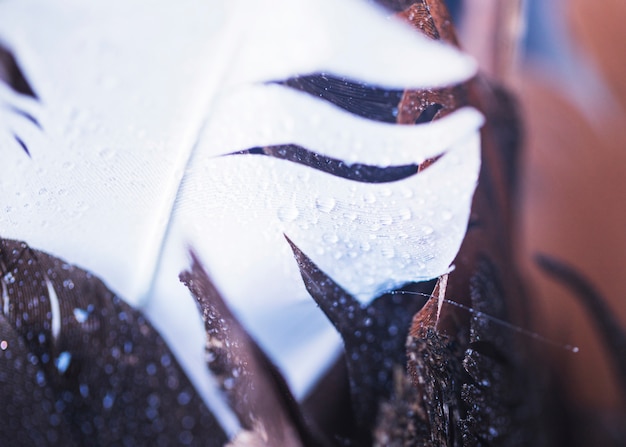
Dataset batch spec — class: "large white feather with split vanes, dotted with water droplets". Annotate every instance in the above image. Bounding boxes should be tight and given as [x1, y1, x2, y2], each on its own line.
[0, 0, 480, 402]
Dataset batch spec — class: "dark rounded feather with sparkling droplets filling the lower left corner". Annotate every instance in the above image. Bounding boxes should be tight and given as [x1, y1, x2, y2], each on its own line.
[0, 239, 226, 446]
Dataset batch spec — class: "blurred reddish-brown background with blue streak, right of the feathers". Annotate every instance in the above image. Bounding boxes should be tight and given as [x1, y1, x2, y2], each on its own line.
[449, 0, 626, 420]
